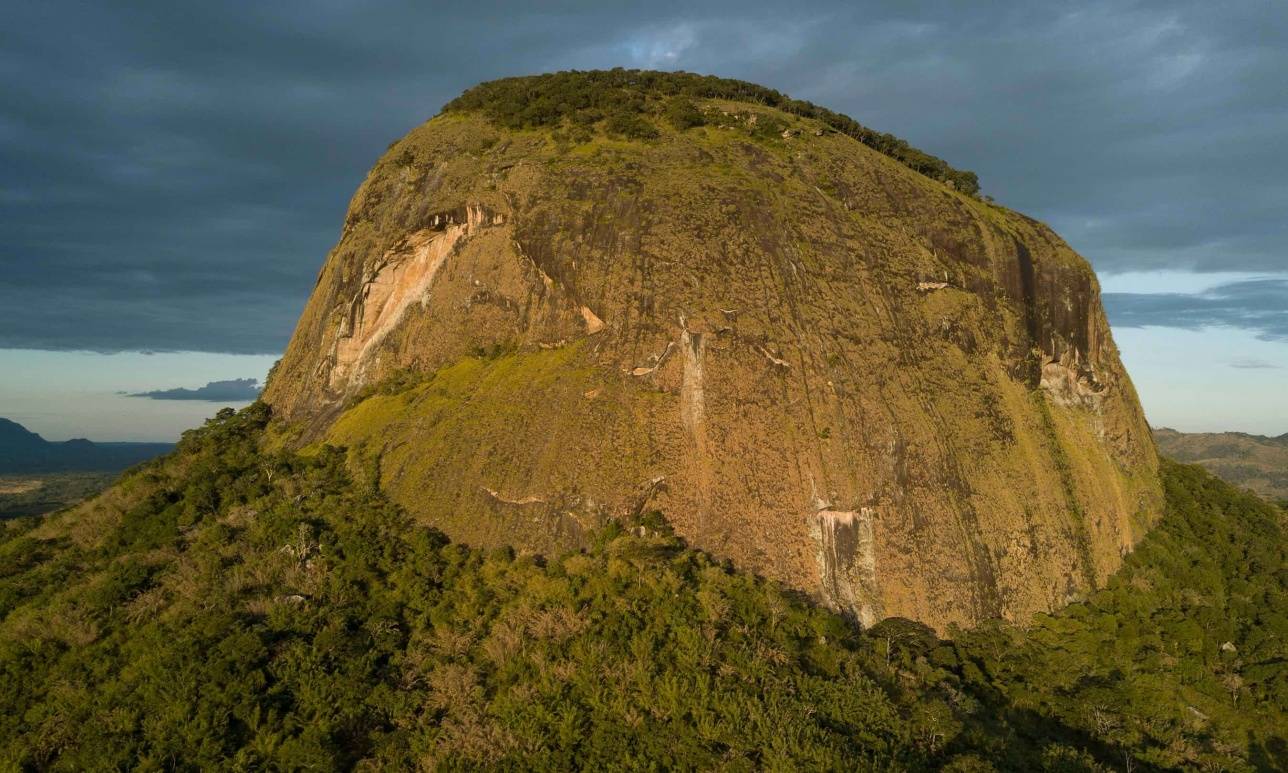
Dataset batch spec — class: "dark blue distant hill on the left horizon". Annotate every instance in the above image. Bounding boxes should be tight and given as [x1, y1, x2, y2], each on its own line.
[0, 419, 174, 474]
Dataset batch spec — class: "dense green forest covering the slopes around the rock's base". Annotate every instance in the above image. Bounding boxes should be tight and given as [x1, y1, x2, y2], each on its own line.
[0, 403, 1288, 770]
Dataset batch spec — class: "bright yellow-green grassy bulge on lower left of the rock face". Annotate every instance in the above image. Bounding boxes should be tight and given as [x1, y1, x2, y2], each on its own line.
[326, 345, 657, 551]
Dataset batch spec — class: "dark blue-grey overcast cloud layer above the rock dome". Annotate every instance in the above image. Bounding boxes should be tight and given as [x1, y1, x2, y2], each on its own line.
[0, 0, 1288, 353]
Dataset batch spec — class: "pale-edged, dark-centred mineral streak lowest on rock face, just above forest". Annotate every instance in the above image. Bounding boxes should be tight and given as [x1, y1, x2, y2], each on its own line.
[811, 508, 882, 627]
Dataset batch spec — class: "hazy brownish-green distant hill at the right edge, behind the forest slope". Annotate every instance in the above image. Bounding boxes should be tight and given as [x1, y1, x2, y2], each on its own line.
[1154, 426, 1288, 501]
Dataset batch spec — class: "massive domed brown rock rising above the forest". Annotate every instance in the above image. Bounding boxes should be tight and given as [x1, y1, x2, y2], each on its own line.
[264, 73, 1160, 629]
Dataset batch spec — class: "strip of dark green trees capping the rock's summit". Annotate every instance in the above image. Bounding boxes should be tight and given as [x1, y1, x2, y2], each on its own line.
[443, 67, 979, 195]
